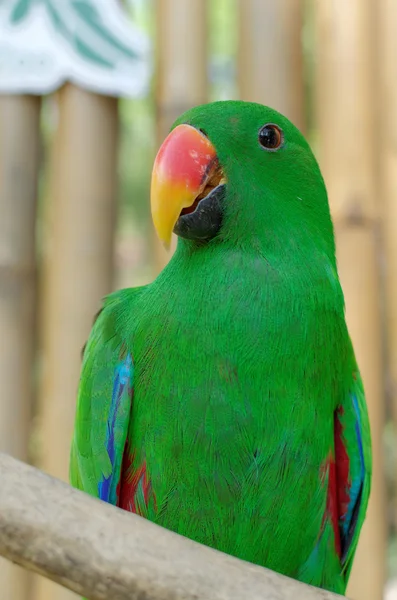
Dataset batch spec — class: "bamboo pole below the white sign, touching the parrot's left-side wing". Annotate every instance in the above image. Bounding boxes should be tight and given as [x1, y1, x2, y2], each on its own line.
[36, 84, 118, 600]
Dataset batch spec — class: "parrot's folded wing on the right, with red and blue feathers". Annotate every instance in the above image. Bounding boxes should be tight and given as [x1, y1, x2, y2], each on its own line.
[330, 370, 372, 579]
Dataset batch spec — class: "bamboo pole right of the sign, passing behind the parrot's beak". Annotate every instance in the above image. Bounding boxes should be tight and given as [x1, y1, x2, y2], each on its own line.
[154, 0, 208, 270]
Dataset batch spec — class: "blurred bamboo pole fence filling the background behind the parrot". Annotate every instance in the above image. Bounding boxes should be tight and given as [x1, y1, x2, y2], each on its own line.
[0, 0, 397, 600]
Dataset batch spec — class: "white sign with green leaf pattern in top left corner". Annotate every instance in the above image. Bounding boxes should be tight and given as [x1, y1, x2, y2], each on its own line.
[0, 0, 150, 97]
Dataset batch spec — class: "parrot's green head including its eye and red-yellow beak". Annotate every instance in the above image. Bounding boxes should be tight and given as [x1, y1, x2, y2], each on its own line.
[151, 101, 335, 260]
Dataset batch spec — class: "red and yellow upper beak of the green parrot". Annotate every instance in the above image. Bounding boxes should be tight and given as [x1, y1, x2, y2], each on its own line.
[150, 125, 218, 246]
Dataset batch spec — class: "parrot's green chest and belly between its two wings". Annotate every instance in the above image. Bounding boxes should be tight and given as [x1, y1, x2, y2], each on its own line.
[122, 254, 341, 573]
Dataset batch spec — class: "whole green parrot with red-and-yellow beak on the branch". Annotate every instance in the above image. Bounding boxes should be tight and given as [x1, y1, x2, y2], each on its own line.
[70, 101, 371, 594]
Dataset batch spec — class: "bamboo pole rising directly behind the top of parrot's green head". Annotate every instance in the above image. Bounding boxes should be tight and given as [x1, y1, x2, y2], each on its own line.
[239, 0, 305, 131]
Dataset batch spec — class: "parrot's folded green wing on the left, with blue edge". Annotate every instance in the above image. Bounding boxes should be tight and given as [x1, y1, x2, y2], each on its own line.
[70, 288, 142, 505]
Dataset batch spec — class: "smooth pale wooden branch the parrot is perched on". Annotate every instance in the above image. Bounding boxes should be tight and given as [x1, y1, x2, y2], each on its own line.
[0, 454, 341, 600]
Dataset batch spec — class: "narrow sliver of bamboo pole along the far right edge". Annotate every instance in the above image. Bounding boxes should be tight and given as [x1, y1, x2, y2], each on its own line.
[378, 0, 397, 536]
